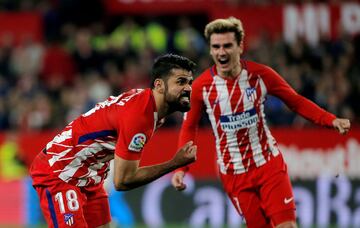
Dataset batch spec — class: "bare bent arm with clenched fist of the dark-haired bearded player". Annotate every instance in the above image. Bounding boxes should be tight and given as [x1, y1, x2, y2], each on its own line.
[114, 141, 197, 191]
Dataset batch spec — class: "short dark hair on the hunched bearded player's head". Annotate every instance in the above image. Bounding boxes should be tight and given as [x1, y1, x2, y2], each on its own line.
[151, 54, 196, 88]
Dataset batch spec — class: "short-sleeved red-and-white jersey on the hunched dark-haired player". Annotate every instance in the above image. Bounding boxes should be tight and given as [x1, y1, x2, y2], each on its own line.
[30, 89, 157, 186]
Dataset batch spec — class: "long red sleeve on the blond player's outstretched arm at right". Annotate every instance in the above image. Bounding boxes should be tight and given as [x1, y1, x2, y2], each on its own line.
[262, 67, 336, 127]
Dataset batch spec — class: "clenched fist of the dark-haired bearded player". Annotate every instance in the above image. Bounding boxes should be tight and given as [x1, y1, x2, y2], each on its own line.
[172, 141, 197, 167]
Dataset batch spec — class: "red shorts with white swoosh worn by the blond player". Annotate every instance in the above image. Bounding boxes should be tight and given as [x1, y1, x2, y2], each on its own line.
[220, 155, 295, 228]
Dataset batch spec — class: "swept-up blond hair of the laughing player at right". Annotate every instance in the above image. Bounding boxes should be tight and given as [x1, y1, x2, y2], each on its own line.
[204, 17, 245, 44]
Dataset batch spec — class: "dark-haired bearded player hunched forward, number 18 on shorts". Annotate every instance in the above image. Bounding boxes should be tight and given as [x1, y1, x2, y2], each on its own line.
[30, 54, 197, 227]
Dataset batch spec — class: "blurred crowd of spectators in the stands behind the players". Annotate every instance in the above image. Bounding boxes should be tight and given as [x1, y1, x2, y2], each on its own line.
[0, 1, 360, 131]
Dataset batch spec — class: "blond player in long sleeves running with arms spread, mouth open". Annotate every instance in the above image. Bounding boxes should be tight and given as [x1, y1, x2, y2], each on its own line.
[172, 17, 350, 228]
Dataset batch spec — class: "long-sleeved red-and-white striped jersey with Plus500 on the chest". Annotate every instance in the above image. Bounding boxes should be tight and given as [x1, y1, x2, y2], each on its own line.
[179, 60, 335, 174]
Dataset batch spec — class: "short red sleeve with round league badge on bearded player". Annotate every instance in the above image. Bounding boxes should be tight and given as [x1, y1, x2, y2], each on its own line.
[115, 108, 153, 160]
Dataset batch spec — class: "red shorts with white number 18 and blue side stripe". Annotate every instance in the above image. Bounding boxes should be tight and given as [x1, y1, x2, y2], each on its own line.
[35, 180, 111, 228]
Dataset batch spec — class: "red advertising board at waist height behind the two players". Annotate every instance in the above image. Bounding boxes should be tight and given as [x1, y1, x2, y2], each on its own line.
[0, 128, 360, 178]
